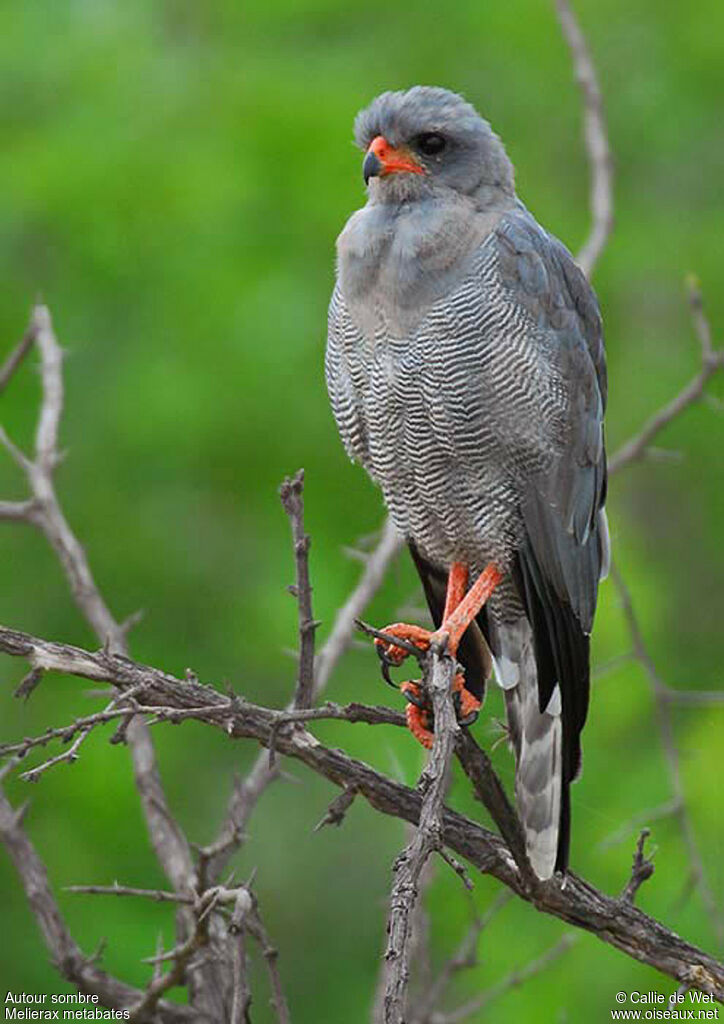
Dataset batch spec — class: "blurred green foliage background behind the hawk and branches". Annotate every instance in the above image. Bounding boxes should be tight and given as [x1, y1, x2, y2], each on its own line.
[0, 0, 724, 1024]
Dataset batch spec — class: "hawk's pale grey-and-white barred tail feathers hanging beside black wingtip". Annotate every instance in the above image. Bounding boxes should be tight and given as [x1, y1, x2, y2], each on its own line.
[495, 618, 568, 879]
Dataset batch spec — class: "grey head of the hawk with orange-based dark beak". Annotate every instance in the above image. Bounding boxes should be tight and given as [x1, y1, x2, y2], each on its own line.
[354, 85, 514, 205]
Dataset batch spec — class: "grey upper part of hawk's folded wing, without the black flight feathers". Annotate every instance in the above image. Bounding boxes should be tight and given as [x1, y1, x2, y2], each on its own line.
[498, 212, 608, 618]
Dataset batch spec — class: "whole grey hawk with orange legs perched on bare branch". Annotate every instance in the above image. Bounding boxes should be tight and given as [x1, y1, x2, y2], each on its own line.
[325, 85, 610, 880]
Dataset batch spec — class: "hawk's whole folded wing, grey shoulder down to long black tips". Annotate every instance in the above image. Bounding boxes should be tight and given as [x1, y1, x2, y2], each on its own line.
[498, 210, 608, 867]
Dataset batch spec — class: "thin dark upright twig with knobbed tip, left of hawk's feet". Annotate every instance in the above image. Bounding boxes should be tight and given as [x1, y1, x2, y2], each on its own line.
[280, 469, 320, 709]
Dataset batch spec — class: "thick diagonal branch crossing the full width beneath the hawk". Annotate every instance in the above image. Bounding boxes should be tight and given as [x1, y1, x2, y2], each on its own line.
[0, 627, 724, 999]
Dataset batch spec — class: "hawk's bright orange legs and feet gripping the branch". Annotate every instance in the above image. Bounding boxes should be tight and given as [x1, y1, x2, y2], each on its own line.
[375, 562, 503, 749]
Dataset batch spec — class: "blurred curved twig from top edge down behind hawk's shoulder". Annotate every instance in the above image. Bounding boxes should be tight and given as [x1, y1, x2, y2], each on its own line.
[555, 0, 613, 278]
